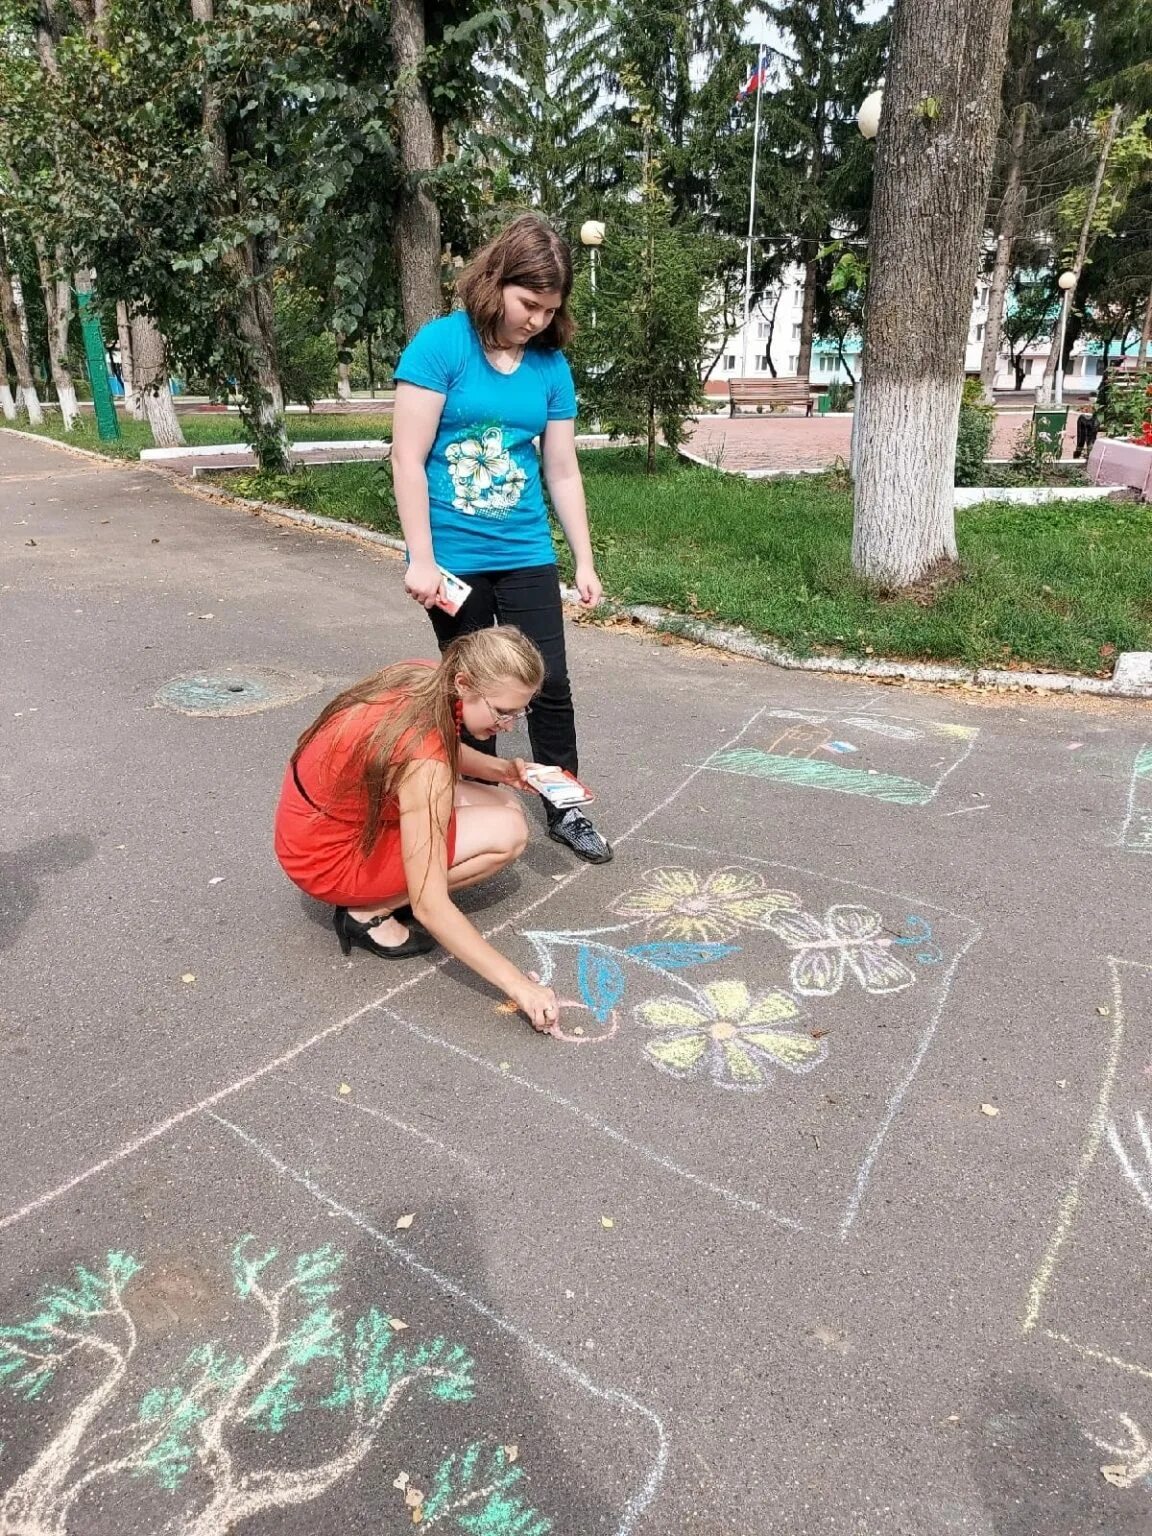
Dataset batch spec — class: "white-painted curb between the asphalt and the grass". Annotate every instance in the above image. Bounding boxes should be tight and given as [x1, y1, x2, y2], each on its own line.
[6, 427, 1152, 699]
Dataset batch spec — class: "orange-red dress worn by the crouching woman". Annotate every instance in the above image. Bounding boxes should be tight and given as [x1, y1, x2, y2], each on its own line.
[275, 693, 456, 906]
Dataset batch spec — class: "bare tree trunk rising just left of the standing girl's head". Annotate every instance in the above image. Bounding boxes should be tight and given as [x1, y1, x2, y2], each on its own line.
[392, 0, 444, 338]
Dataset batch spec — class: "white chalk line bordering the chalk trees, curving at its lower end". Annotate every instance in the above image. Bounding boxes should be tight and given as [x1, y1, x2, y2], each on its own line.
[207, 1112, 670, 1536]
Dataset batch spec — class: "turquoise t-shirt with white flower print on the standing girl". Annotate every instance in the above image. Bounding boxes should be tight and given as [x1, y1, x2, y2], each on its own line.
[395, 310, 576, 576]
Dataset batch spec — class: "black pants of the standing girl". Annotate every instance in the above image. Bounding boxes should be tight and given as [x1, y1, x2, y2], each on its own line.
[429, 565, 578, 774]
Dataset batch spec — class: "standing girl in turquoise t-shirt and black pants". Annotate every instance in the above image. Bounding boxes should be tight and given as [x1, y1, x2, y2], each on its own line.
[392, 215, 611, 863]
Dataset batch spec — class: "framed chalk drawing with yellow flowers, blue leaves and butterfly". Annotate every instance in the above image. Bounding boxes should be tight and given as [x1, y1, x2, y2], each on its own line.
[390, 840, 978, 1238]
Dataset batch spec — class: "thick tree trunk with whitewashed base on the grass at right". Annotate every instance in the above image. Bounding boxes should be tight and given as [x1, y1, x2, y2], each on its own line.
[852, 0, 1011, 588]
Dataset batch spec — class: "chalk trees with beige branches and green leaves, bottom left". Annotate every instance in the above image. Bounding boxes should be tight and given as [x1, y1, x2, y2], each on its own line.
[0, 1236, 553, 1536]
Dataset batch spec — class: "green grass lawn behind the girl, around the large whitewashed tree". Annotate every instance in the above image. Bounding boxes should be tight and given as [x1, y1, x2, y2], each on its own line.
[155, 449, 1152, 676]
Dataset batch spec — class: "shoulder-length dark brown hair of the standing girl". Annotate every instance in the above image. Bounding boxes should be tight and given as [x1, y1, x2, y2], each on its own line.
[456, 214, 576, 347]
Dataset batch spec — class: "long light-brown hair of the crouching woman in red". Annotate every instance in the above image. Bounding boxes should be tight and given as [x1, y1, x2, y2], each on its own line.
[292, 625, 544, 857]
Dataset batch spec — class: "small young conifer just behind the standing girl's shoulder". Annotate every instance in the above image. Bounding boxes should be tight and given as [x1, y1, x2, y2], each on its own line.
[571, 180, 710, 464]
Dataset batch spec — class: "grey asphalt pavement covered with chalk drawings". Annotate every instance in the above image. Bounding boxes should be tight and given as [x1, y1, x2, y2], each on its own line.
[0, 433, 1152, 1536]
